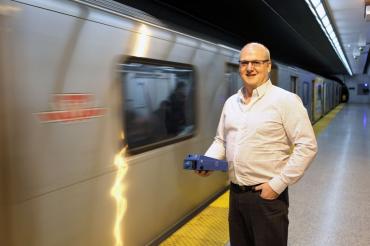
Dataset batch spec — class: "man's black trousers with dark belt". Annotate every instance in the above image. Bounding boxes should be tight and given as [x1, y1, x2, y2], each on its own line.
[229, 184, 289, 246]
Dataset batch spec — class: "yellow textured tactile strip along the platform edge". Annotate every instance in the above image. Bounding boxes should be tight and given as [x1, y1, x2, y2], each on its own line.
[160, 104, 344, 246]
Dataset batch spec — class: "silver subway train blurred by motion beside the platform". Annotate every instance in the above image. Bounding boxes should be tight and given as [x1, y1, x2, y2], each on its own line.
[0, 0, 342, 246]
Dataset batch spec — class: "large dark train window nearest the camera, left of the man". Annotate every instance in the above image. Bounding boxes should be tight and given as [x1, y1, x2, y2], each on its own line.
[120, 57, 195, 154]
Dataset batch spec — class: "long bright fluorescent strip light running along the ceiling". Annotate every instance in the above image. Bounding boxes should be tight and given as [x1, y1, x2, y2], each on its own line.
[305, 0, 354, 76]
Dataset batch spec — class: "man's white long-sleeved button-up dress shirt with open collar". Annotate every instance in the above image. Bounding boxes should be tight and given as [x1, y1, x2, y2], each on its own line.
[205, 80, 317, 194]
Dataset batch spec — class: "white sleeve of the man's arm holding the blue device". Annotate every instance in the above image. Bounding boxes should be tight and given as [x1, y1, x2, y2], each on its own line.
[204, 106, 226, 160]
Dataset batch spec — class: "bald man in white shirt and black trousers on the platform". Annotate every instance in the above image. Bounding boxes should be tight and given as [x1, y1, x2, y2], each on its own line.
[198, 43, 317, 246]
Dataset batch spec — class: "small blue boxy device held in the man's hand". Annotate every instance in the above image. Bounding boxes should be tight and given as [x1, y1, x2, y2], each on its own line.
[184, 154, 228, 172]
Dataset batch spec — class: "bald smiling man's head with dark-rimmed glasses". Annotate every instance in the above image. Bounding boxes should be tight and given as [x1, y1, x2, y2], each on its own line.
[239, 43, 271, 89]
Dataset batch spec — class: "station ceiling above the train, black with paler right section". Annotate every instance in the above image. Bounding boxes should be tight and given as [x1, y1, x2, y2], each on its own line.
[116, 0, 370, 76]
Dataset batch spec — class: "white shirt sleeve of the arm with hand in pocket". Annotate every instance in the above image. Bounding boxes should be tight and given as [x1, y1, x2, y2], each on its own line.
[269, 95, 317, 194]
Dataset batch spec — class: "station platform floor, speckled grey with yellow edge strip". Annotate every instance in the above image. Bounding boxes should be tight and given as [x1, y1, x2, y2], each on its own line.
[161, 104, 370, 246]
